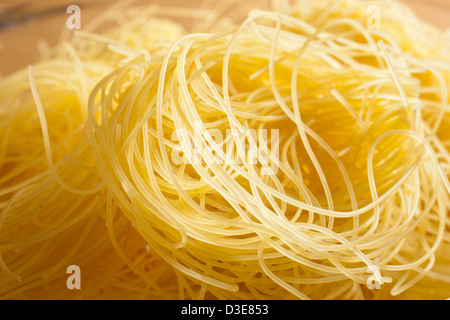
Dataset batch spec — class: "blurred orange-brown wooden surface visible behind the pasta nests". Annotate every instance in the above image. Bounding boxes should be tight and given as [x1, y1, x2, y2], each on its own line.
[0, 0, 450, 76]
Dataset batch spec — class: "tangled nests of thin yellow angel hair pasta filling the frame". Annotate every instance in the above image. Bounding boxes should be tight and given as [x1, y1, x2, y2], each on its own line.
[0, 0, 450, 299]
